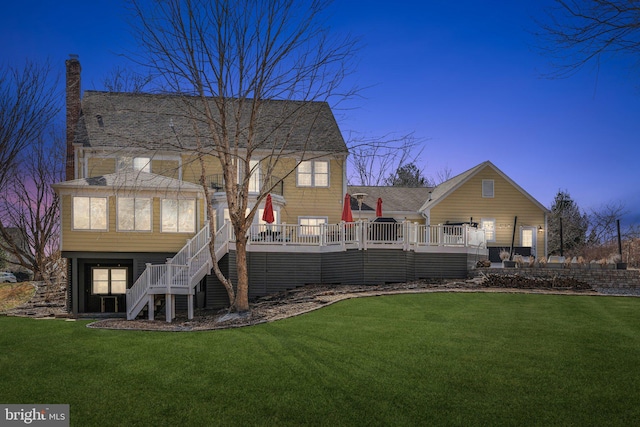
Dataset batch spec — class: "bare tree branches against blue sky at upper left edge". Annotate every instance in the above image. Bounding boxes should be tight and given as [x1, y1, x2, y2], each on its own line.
[0, 61, 60, 191]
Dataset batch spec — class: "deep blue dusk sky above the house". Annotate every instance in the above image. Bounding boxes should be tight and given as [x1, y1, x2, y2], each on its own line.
[0, 0, 640, 225]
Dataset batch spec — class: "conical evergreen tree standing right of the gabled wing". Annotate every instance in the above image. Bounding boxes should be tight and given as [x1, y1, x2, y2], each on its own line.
[548, 190, 589, 256]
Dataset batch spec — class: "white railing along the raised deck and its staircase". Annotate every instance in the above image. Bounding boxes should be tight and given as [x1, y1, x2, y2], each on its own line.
[127, 221, 486, 319]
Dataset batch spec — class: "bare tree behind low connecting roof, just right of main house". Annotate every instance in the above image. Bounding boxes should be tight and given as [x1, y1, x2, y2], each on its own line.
[349, 133, 424, 186]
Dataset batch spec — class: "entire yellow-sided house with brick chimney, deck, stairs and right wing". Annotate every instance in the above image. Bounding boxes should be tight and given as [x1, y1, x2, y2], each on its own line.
[54, 57, 546, 321]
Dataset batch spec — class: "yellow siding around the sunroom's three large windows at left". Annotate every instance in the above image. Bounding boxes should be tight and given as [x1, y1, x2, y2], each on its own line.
[61, 195, 204, 252]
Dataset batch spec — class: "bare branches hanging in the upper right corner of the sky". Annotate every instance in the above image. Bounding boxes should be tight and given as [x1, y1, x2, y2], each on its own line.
[539, 0, 640, 77]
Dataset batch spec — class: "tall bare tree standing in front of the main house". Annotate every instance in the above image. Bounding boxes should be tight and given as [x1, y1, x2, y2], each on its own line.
[131, 0, 355, 311]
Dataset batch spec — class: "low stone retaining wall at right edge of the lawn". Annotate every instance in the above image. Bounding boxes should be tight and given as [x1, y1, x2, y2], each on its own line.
[469, 267, 640, 289]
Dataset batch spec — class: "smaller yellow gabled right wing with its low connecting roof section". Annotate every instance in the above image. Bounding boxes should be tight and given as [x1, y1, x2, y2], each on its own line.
[348, 161, 549, 262]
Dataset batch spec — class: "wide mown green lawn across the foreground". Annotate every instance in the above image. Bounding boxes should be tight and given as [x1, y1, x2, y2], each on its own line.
[0, 293, 640, 426]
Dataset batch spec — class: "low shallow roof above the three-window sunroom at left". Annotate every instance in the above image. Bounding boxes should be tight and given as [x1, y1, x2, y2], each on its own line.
[53, 170, 203, 193]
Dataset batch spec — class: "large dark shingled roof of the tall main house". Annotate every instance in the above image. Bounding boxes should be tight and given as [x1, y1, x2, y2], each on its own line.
[75, 91, 347, 153]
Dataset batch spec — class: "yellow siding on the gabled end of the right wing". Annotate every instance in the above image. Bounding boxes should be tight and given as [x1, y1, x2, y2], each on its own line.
[430, 167, 545, 257]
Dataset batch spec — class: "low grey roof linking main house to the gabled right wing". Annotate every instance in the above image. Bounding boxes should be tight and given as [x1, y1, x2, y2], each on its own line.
[348, 185, 433, 213]
